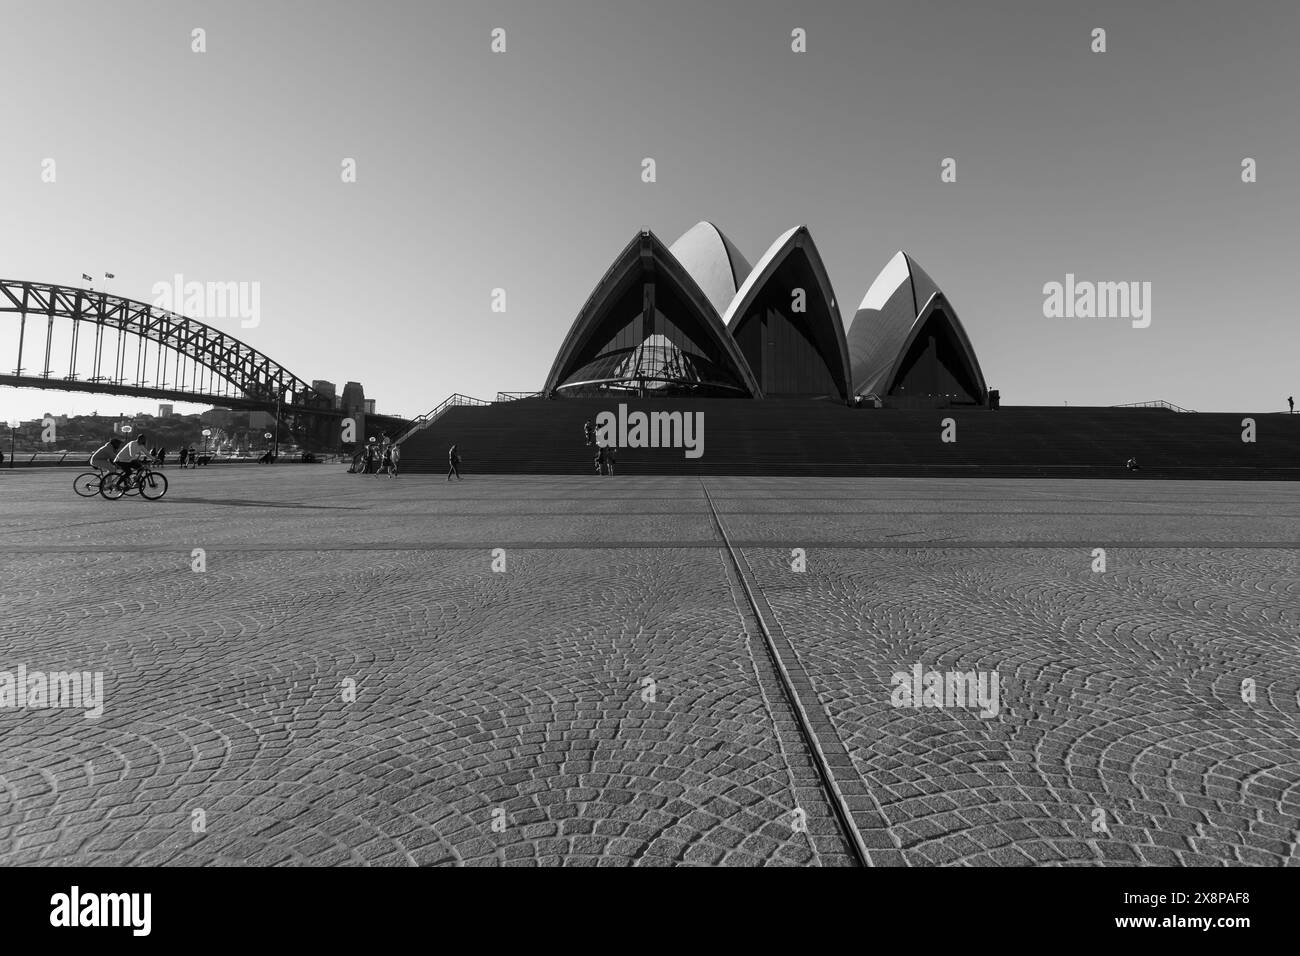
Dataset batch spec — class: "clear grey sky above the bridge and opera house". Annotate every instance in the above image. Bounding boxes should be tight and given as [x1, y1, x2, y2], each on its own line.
[0, 0, 1300, 419]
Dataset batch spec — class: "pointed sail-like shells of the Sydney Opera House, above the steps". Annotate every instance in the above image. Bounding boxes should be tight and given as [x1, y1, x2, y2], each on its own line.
[543, 222, 989, 407]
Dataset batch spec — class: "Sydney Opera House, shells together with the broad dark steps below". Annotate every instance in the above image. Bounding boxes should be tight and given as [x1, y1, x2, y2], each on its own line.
[400, 222, 1300, 479]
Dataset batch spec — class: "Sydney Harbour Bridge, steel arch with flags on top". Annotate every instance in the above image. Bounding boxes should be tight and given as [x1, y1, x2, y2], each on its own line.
[0, 280, 397, 450]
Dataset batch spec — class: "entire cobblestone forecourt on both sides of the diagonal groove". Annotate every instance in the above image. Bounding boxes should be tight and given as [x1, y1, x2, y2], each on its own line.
[0, 466, 1300, 865]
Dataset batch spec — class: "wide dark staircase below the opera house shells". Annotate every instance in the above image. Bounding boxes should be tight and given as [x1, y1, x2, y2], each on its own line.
[402, 398, 1300, 480]
